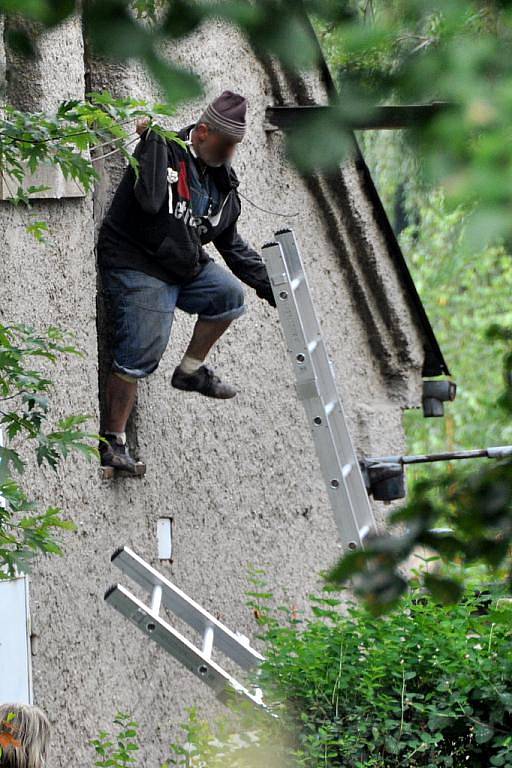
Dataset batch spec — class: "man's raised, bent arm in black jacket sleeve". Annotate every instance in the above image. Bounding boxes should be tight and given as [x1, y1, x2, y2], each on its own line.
[133, 130, 167, 214]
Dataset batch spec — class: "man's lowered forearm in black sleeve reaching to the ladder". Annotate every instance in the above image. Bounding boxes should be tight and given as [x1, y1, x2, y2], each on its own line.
[213, 221, 276, 307]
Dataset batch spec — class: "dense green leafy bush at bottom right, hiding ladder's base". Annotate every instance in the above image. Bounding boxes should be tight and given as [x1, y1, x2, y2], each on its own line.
[97, 580, 512, 768]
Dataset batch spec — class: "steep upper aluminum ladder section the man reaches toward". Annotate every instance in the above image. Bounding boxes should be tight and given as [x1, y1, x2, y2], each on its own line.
[262, 229, 376, 549]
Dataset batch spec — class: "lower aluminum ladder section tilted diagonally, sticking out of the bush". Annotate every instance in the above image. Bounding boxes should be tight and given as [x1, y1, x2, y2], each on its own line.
[105, 547, 275, 716]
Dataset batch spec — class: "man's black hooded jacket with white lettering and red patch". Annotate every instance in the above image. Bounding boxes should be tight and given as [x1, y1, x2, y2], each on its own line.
[97, 123, 275, 306]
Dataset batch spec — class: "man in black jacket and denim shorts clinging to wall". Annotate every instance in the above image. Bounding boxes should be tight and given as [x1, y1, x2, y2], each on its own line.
[97, 91, 276, 472]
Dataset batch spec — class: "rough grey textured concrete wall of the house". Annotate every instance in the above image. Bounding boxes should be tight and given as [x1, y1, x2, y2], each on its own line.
[0, 13, 428, 768]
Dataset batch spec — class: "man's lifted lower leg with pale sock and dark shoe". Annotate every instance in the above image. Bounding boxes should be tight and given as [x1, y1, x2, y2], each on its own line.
[171, 319, 236, 399]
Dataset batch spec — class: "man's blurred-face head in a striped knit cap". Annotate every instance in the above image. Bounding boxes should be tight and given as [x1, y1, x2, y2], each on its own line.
[192, 91, 247, 167]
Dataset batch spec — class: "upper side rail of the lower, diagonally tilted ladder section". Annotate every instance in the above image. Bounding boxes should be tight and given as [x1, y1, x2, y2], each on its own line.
[112, 547, 263, 670]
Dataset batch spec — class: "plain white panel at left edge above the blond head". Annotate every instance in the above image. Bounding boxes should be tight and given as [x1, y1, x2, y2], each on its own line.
[0, 576, 32, 704]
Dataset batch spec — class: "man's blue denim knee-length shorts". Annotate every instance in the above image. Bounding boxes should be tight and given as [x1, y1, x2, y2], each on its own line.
[100, 260, 247, 379]
